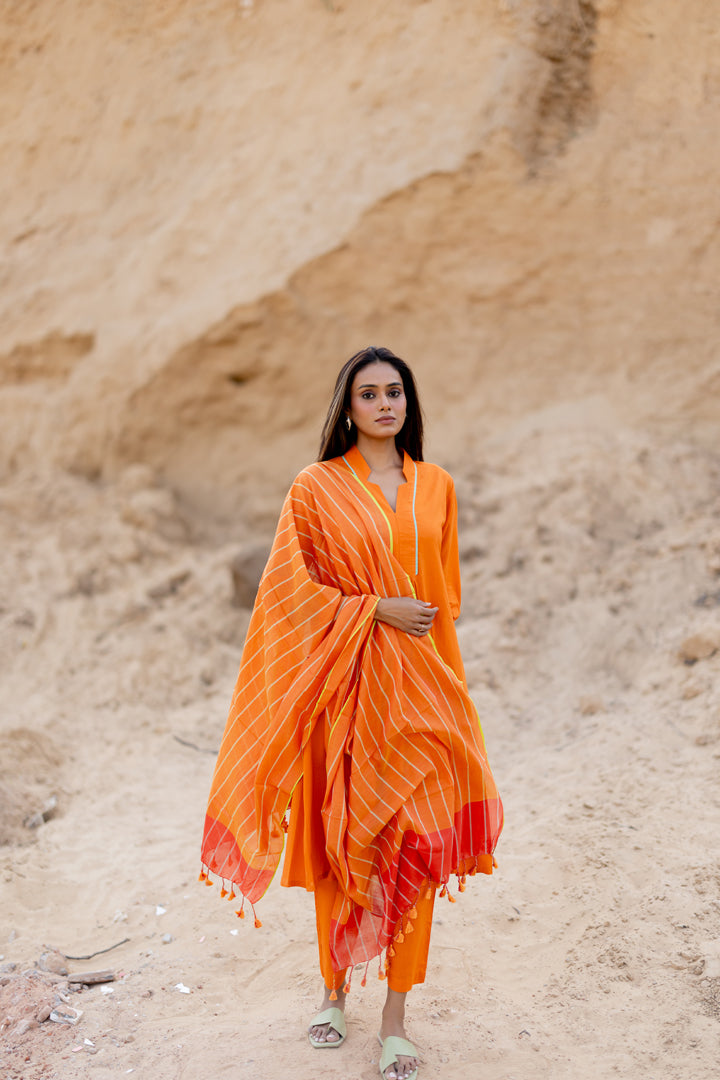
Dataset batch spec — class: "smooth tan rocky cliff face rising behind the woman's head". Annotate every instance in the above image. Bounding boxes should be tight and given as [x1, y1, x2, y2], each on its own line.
[0, 0, 720, 515]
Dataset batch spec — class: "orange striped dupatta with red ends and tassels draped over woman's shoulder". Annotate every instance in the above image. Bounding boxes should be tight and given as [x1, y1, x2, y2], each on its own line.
[201, 458, 502, 970]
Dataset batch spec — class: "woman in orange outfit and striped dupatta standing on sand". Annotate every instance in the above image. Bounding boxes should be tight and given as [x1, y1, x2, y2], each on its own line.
[201, 348, 502, 1080]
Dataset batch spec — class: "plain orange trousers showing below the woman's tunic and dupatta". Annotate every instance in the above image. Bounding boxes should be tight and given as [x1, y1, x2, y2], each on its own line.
[315, 877, 435, 994]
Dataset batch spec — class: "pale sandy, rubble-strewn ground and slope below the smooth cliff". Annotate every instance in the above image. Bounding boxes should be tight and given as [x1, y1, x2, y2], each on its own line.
[0, 417, 720, 1080]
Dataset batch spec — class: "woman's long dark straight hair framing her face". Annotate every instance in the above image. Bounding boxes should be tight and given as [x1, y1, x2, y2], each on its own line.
[317, 345, 422, 461]
